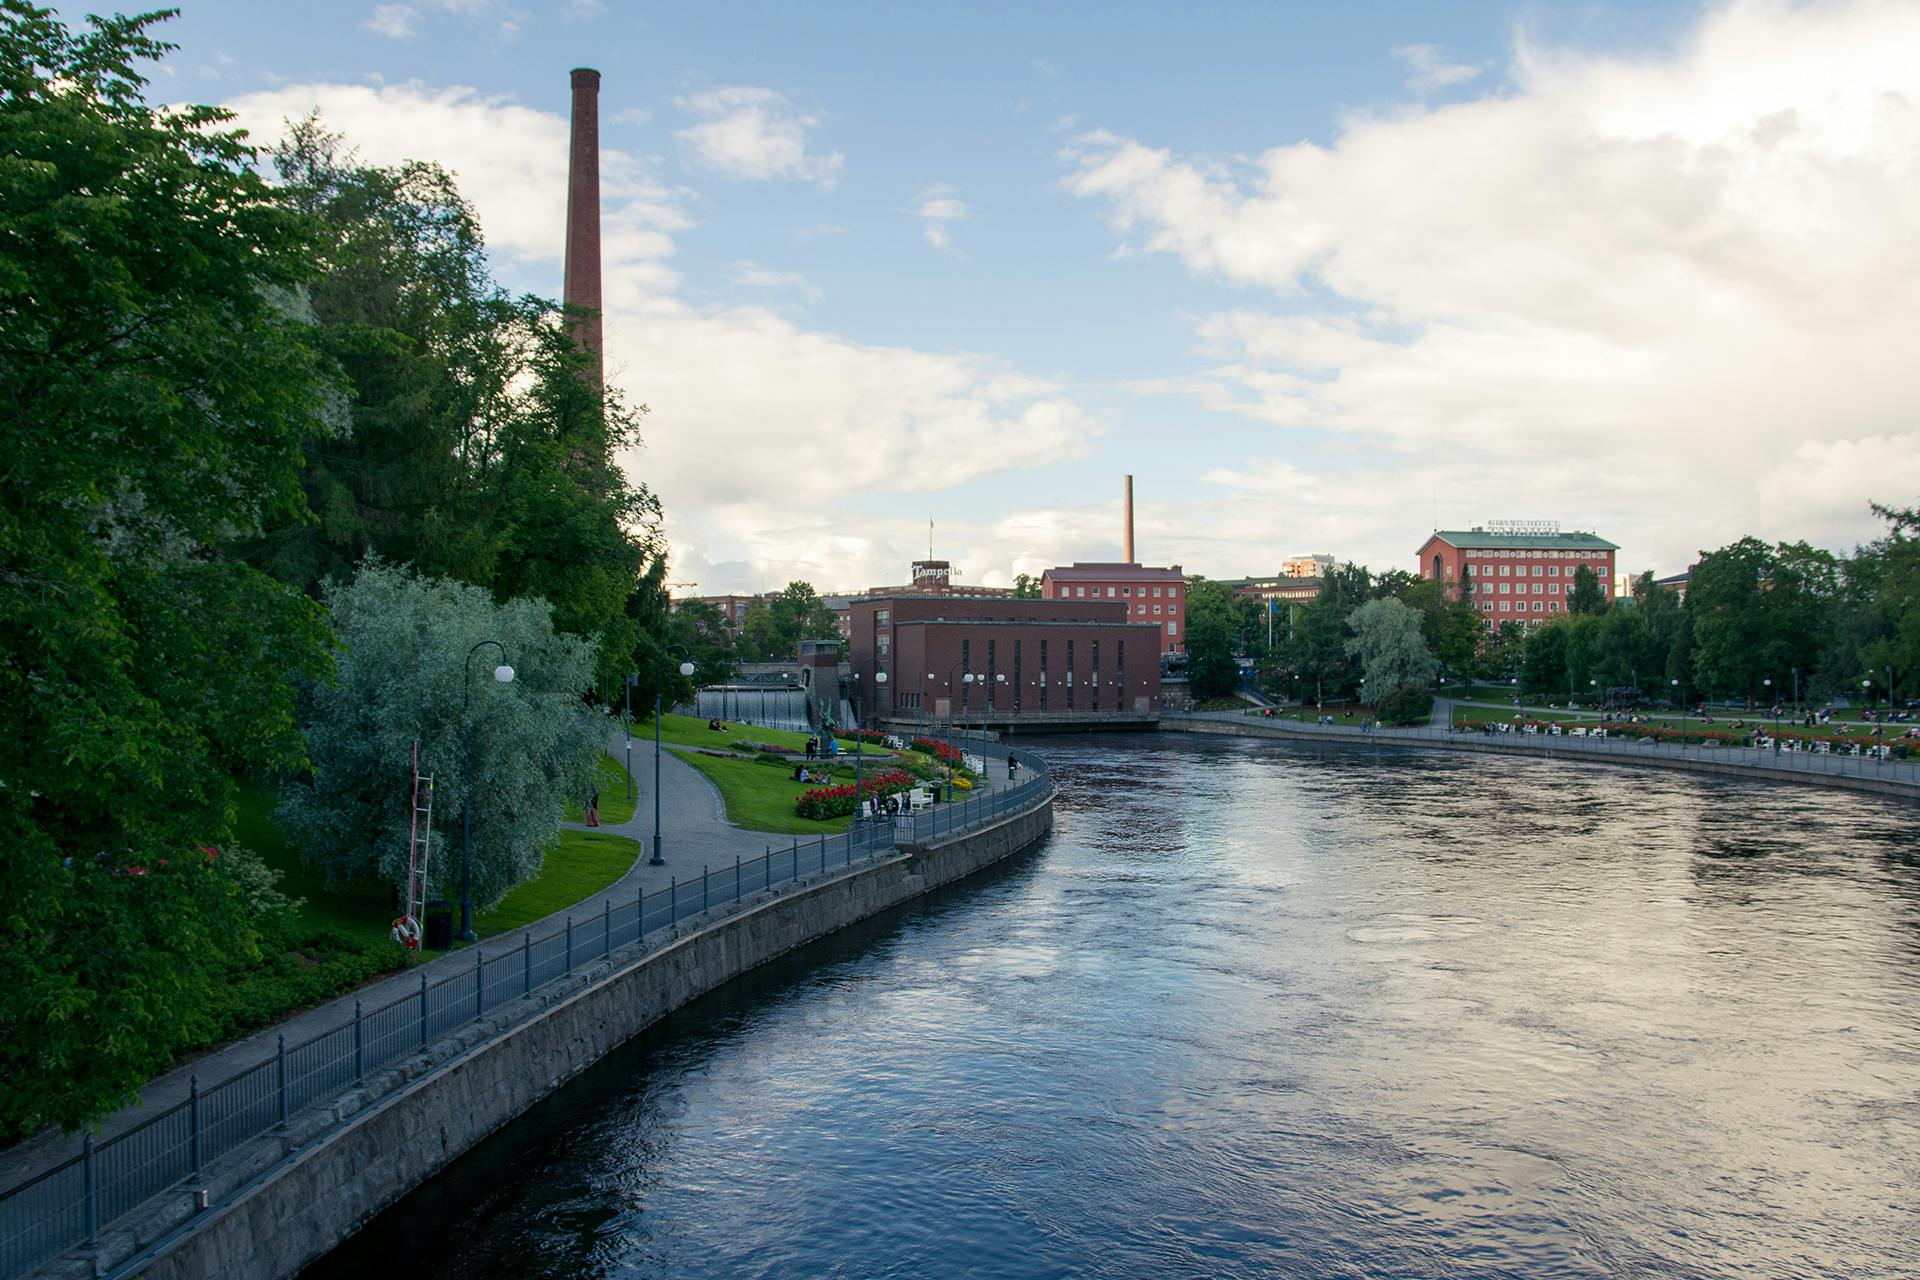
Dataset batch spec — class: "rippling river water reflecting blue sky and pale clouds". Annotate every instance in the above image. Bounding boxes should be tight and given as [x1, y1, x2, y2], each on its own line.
[309, 737, 1920, 1280]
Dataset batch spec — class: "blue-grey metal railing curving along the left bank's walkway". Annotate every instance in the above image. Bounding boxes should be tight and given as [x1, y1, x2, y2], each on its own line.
[0, 748, 1046, 1280]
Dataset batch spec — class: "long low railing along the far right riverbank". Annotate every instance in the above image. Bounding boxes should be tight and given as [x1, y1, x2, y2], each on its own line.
[1169, 712, 1920, 787]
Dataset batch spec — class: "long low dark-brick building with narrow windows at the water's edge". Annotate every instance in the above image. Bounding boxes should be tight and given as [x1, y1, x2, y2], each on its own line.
[849, 595, 1165, 720]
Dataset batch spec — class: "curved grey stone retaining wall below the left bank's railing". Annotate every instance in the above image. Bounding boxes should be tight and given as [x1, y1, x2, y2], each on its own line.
[67, 794, 1054, 1280]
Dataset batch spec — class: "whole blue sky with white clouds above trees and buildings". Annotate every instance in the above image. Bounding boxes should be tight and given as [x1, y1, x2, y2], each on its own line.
[127, 0, 1920, 595]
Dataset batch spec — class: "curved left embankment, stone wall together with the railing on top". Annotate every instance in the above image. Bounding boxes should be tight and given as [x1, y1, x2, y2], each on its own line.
[0, 744, 1052, 1276]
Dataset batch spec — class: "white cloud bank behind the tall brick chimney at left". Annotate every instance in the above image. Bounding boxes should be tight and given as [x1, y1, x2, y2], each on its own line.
[228, 84, 1104, 591]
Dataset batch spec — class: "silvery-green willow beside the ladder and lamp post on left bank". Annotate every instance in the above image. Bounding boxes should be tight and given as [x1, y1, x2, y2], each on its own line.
[280, 560, 605, 906]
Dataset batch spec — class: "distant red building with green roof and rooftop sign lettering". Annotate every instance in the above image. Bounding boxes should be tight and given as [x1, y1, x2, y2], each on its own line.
[1419, 520, 1619, 626]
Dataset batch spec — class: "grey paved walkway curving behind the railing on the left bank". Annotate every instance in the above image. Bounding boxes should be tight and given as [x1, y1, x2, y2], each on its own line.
[0, 729, 1006, 1190]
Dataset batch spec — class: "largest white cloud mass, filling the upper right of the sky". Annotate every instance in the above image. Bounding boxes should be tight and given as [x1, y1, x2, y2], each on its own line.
[1064, 0, 1920, 566]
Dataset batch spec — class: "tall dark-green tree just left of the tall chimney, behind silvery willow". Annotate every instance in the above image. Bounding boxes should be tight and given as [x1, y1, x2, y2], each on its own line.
[242, 117, 664, 681]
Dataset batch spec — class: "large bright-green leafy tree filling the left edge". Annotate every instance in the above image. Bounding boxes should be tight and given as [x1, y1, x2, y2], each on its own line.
[0, 0, 338, 1136]
